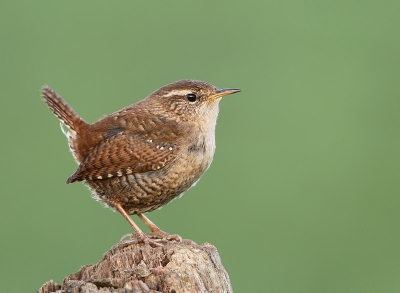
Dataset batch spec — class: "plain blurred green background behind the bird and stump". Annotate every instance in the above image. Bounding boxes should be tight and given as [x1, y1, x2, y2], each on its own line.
[0, 0, 400, 293]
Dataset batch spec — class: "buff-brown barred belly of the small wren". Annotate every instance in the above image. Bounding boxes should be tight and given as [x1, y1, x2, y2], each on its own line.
[86, 152, 212, 215]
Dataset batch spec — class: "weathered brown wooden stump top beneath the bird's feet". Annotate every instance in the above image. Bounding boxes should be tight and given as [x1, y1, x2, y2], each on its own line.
[37, 240, 232, 293]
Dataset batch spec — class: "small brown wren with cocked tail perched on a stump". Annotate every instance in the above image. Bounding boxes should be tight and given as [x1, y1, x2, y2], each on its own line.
[42, 80, 240, 245]
